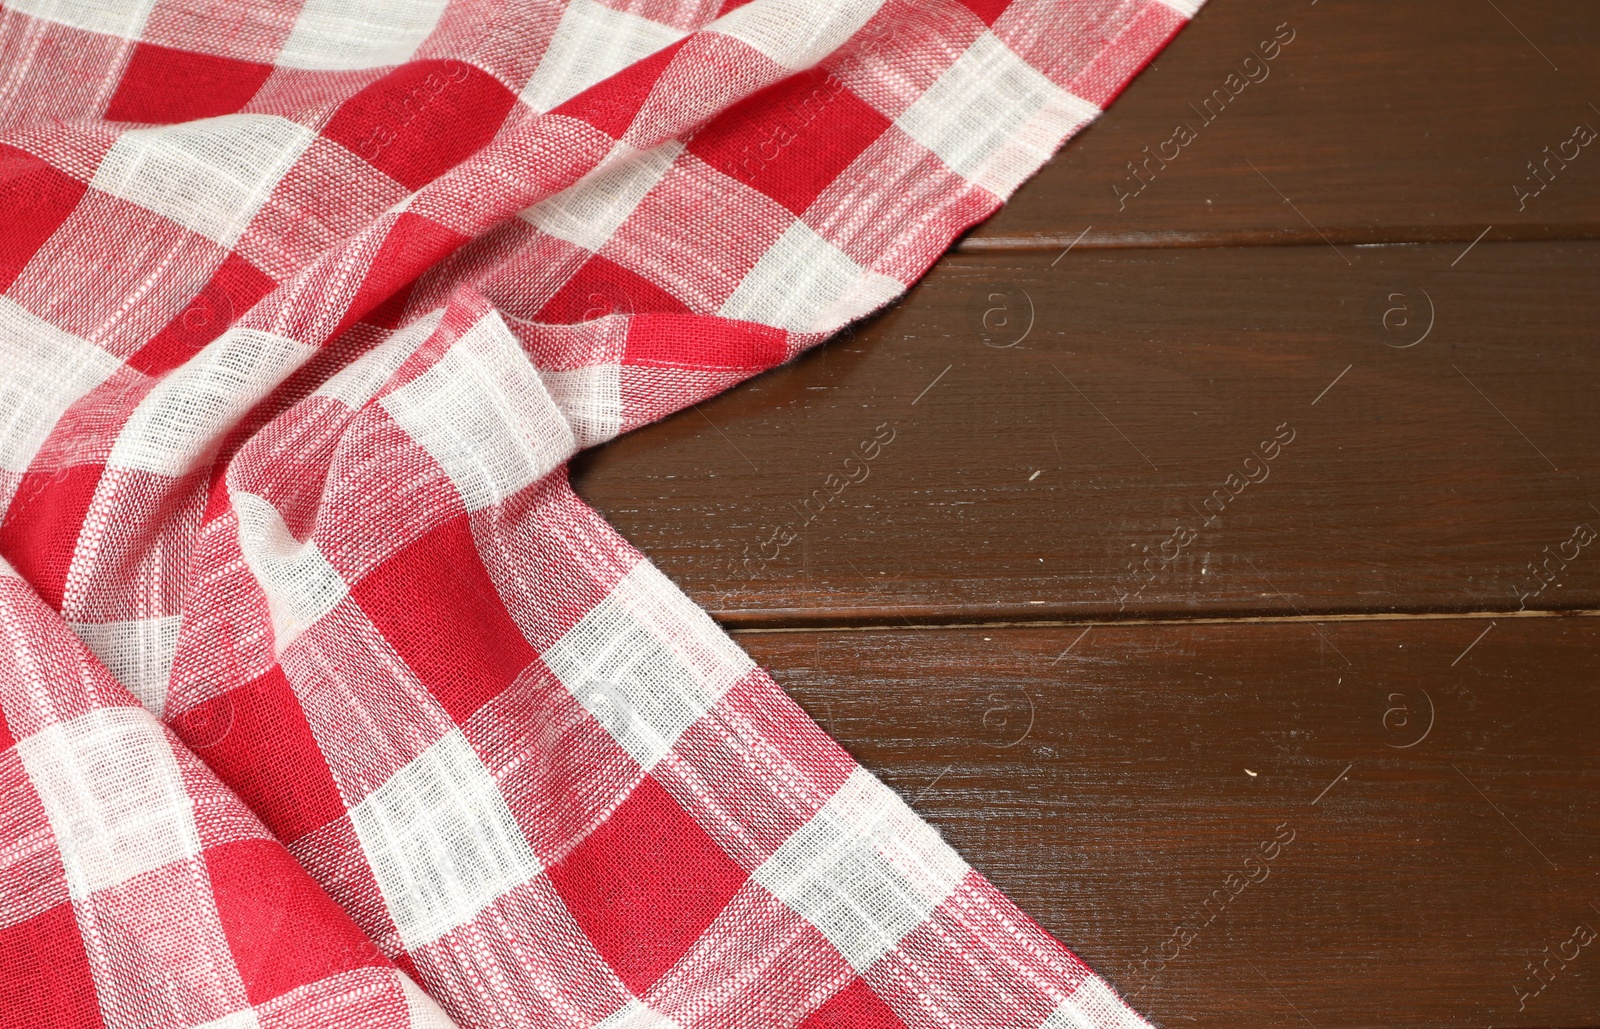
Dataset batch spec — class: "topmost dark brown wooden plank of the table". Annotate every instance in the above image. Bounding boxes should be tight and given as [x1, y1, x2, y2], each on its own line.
[962, 0, 1600, 250]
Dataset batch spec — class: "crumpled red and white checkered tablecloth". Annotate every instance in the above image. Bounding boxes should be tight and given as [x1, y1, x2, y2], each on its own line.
[0, 0, 1197, 1029]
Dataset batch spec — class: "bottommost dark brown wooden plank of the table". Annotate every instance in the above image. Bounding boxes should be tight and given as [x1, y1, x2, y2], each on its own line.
[739, 618, 1600, 1029]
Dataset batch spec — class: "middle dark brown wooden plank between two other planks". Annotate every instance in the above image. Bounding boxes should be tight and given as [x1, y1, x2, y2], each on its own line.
[574, 243, 1600, 626]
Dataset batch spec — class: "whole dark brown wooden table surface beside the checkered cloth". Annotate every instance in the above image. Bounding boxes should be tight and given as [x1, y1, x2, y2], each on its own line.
[576, 0, 1600, 1029]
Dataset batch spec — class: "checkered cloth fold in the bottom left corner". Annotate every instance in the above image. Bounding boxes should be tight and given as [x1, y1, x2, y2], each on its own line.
[0, 562, 454, 1029]
